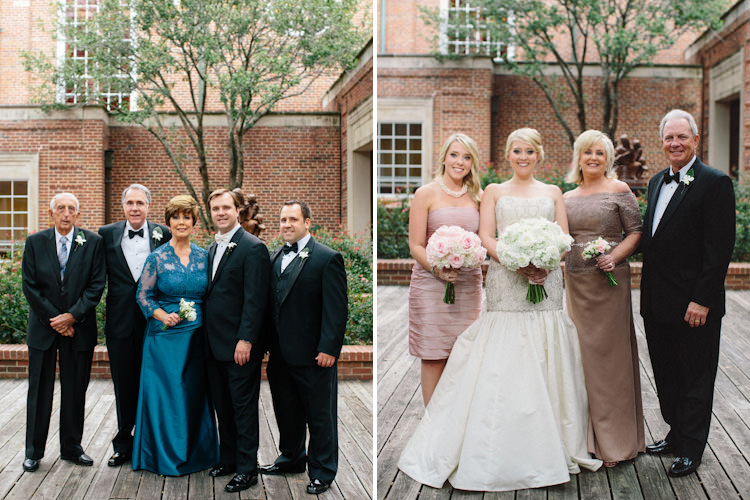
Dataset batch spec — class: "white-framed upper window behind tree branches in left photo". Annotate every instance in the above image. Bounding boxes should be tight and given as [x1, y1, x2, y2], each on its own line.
[58, 0, 134, 111]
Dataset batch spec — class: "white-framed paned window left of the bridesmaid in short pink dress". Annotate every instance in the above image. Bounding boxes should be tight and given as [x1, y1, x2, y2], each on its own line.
[378, 122, 423, 196]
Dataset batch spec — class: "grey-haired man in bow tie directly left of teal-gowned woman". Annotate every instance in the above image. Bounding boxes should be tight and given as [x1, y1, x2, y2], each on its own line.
[99, 184, 172, 467]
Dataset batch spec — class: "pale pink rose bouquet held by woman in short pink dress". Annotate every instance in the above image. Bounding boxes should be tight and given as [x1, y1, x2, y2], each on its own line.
[426, 226, 487, 304]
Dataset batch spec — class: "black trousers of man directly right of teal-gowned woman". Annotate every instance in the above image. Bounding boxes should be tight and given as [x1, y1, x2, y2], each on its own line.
[206, 355, 263, 474]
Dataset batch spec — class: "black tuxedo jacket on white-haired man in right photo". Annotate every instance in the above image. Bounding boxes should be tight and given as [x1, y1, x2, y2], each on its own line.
[640, 159, 735, 323]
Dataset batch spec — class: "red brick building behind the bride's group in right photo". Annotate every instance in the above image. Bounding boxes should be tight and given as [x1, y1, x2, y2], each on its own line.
[376, 0, 750, 197]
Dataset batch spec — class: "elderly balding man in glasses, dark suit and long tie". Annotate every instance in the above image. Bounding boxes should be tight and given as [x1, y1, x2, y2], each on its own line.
[22, 193, 105, 472]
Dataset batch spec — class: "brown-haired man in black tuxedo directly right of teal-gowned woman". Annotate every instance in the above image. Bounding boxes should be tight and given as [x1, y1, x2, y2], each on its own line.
[203, 189, 270, 492]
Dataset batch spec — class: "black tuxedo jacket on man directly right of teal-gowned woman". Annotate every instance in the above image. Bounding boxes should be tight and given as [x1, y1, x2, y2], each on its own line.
[203, 228, 271, 361]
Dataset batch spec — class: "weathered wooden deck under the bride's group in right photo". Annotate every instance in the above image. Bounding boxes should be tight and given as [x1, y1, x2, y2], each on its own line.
[376, 286, 750, 500]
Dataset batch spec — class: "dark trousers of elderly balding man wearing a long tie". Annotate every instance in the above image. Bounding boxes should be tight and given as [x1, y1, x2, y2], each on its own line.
[26, 337, 94, 460]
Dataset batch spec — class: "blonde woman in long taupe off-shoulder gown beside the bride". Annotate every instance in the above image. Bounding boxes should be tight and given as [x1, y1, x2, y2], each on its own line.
[565, 130, 645, 467]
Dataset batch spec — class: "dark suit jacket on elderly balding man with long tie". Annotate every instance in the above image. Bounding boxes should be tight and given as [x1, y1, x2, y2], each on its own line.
[22, 226, 105, 351]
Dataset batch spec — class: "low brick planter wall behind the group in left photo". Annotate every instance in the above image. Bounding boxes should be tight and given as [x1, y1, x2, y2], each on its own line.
[0, 344, 373, 380]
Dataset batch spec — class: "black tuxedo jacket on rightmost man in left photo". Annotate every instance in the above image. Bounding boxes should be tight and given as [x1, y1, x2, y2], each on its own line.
[271, 238, 349, 366]
